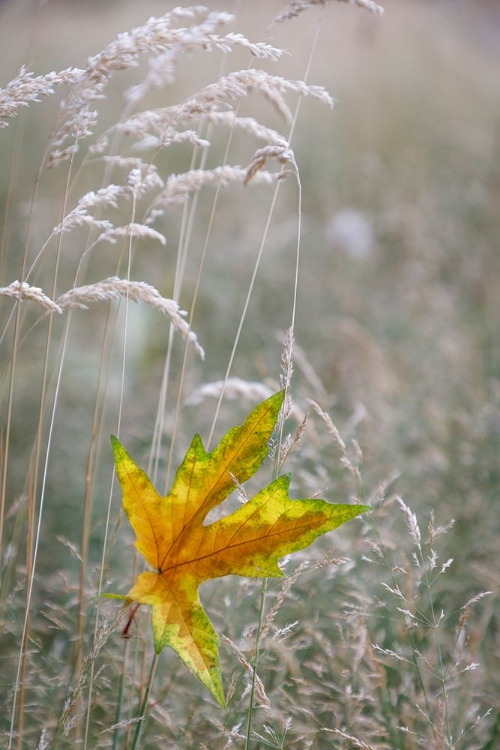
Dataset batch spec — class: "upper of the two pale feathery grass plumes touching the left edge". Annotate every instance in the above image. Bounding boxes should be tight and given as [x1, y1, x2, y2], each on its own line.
[0, 65, 83, 128]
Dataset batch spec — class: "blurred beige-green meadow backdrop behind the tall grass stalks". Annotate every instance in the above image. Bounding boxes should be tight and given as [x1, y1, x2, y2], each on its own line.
[0, 0, 500, 747]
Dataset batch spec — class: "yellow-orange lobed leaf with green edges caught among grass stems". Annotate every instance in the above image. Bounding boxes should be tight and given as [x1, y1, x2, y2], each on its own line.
[111, 391, 369, 705]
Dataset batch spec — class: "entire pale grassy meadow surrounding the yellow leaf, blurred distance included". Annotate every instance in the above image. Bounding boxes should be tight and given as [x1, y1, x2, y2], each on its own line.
[0, 0, 500, 750]
